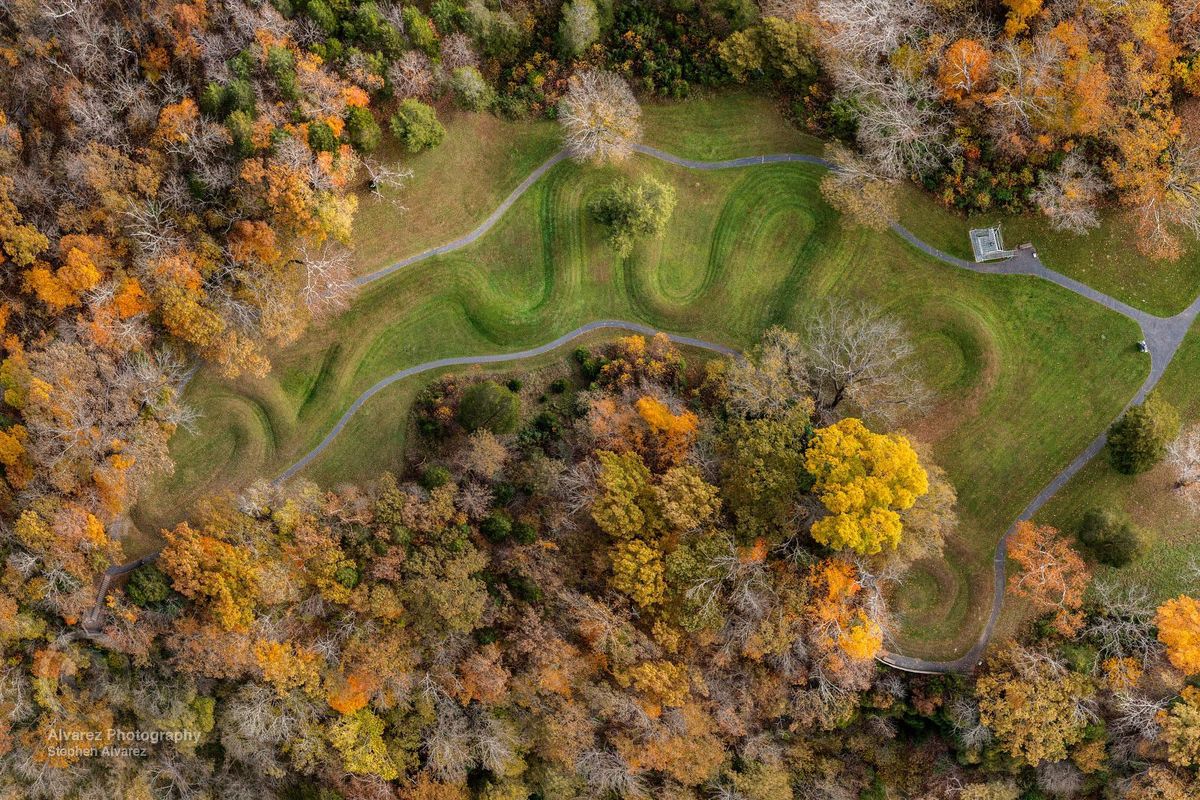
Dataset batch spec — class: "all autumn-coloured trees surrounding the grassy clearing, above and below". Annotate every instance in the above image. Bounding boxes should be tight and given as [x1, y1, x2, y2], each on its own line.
[0, 0, 1200, 800]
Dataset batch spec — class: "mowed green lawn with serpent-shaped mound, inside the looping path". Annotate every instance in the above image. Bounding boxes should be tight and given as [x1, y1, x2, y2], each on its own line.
[136, 96, 1146, 657]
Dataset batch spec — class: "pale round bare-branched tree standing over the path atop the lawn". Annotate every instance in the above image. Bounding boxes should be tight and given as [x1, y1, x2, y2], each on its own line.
[558, 70, 642, 163]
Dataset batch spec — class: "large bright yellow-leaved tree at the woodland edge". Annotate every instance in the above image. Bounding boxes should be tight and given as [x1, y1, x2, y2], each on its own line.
[804, 417, 929, 555]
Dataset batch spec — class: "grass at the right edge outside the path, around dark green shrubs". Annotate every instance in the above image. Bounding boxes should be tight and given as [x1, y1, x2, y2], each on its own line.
[1038, 316, 1200, 599]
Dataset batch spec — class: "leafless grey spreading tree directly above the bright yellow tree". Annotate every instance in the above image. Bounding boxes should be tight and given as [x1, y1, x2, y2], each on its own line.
[808, 303, 930, 421]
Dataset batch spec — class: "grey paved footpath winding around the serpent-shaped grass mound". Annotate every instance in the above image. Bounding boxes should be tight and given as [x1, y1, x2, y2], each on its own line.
[96, 145, 1200, 674]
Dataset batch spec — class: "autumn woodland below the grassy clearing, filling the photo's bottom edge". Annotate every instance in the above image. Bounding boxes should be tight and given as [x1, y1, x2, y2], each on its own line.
[4, 326, 1200, 800]
